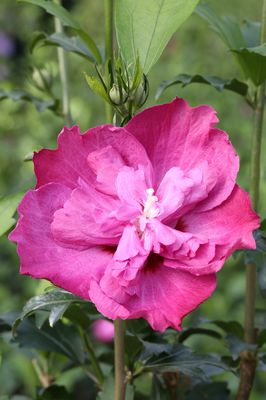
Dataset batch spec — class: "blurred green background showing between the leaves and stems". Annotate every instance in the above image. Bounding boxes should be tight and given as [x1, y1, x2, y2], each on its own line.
[0, 0, 266, 400]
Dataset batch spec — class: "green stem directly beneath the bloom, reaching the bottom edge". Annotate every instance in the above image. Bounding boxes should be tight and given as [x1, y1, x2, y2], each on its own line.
[114, 319, 126, 400]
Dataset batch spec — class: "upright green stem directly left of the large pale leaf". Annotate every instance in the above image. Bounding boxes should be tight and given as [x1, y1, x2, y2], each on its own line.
[104, 0, 114, 124]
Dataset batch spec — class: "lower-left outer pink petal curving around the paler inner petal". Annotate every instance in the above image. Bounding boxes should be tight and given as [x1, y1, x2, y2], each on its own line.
[10, 183, 113, 299]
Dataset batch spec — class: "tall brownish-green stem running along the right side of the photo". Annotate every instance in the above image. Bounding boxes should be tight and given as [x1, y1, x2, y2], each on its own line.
[237, 0, 266, 400]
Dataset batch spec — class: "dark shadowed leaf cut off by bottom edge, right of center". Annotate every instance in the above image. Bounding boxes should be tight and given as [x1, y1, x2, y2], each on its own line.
[186, 382, 230, 400]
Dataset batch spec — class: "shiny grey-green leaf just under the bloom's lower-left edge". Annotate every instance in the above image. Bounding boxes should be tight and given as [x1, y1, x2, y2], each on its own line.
[13, 289, 86, 332]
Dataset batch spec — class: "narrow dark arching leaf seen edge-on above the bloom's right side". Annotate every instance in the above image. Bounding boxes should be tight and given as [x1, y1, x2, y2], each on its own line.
[155, 74, 248, 100]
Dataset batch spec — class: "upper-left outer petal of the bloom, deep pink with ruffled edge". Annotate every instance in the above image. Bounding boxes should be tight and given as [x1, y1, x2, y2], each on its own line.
[33, 125, 153, 188]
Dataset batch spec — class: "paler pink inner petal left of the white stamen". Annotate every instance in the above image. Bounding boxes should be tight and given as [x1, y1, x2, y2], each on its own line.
[51, 180, 122, 250]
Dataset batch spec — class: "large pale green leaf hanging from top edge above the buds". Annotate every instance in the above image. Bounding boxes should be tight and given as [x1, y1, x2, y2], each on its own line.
[115, 0, 198, 74]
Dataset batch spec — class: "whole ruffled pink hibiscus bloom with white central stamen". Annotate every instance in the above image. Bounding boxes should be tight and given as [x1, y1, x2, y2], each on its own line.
[10, 99, 259, 331]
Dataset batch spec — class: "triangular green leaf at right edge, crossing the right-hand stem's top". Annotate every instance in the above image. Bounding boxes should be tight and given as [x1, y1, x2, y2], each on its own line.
[232, 43, 266, 86]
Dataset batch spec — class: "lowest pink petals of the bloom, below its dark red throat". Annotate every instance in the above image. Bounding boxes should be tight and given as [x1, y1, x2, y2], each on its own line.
[90, 255, 216, 332]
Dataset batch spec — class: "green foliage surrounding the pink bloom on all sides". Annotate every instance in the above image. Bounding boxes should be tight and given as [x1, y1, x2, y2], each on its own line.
[0, 0, 266, 400]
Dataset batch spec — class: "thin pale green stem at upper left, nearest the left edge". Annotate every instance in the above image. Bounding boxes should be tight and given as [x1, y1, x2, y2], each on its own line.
[54, 0, 72, 126]
